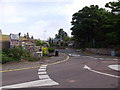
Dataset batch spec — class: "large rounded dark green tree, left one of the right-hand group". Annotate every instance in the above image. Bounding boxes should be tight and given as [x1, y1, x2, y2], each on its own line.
[71, 5, 107, 48]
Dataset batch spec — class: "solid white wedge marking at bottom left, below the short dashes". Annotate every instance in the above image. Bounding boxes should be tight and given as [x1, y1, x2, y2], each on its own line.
[0, 79, 59, 89]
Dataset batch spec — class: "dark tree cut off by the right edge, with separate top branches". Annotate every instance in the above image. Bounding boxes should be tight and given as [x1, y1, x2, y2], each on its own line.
[105, 1, 120, 47]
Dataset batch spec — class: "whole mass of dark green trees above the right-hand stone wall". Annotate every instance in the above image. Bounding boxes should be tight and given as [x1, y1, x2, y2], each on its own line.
[71, 2, 120, 48]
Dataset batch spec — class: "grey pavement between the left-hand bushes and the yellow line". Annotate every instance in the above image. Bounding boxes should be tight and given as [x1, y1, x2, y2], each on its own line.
[2, 53, 66, 71]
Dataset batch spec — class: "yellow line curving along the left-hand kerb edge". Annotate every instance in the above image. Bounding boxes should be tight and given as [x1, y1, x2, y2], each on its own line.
[0, 53, 70, 72]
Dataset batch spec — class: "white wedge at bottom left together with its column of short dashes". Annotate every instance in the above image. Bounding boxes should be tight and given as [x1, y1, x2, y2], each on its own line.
[0, 65, 59, 89]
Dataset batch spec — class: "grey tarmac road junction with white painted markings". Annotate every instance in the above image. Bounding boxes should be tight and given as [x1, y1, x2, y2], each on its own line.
[2, 49, 120, 88]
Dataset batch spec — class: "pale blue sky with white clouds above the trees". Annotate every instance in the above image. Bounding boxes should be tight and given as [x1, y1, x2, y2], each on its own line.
[0, 0, 117, 40]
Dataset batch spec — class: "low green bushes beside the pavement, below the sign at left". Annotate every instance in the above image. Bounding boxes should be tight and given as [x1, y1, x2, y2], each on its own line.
[0, 46, 38, 64]
